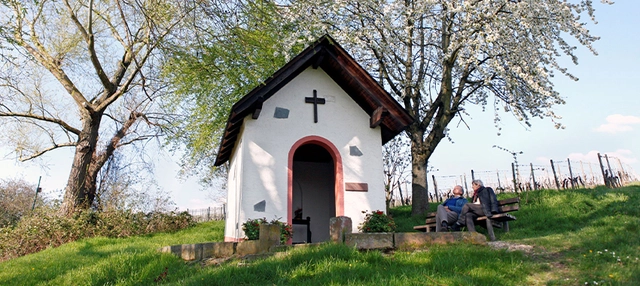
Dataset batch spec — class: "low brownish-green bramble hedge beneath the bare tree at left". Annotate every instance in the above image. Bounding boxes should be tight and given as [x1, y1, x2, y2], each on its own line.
[0, 208, 195, 261]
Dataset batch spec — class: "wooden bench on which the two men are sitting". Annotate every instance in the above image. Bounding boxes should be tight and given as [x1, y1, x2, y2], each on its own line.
[413, 197, 520, 241]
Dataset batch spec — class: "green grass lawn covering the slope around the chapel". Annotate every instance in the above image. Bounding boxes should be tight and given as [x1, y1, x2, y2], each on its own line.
[0, 186, 640, 285]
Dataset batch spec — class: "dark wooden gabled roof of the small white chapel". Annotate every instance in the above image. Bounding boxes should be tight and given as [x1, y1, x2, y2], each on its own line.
[214, 35, 413, 166]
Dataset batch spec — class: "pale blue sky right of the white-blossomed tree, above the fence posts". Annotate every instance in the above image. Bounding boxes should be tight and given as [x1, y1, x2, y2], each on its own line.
[430, 1, 640, 188]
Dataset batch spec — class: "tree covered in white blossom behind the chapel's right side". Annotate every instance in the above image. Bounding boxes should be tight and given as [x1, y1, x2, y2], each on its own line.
[286, 0, 610, 215]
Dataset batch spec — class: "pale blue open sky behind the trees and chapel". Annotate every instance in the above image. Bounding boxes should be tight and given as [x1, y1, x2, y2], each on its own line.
[0, 1, 640, 210]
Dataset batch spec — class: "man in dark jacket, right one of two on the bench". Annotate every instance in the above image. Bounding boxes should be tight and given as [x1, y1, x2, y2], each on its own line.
[456, 180, 500, 231]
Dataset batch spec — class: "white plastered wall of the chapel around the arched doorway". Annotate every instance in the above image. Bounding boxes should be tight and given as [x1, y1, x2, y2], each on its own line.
[225, 67, 385, 238]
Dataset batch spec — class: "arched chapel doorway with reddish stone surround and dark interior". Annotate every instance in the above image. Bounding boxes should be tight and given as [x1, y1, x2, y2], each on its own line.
[287, 136, 344, 242]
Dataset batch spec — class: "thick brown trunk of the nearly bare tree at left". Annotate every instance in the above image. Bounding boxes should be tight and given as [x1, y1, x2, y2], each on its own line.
[60, 113, 102, 215]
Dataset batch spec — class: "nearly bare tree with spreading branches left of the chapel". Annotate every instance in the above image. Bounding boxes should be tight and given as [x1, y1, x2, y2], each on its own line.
[0, 0, 193, 214]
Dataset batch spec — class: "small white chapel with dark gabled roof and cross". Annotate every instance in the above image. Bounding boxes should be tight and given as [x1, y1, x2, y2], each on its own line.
[215, 35, 413, 242]
